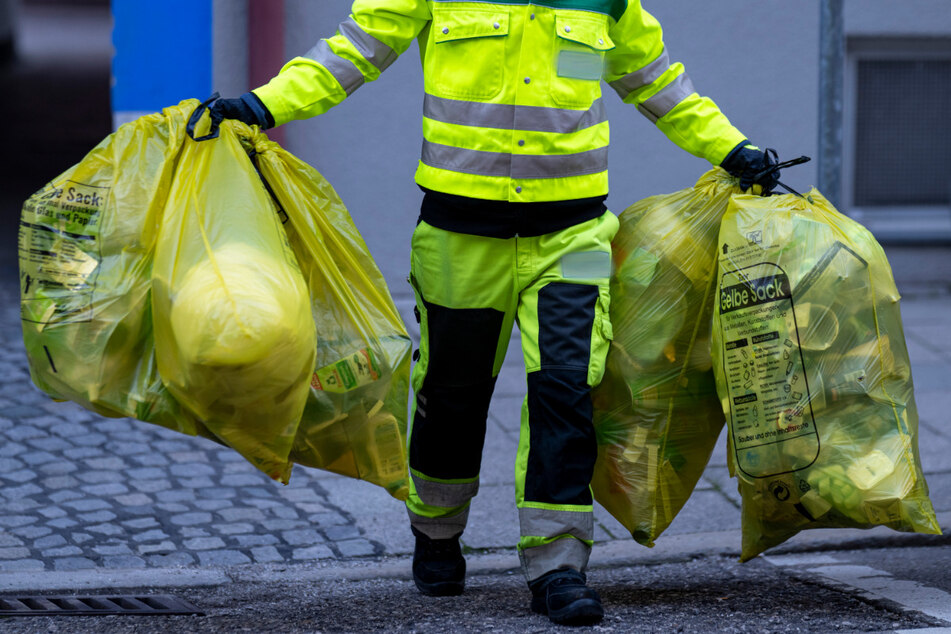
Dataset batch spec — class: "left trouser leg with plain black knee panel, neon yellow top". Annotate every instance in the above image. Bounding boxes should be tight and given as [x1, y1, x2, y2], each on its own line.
[406, 223, 514, 539]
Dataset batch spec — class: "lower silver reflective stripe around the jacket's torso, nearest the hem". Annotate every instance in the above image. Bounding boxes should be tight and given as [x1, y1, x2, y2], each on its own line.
[421, 140, 608, 179]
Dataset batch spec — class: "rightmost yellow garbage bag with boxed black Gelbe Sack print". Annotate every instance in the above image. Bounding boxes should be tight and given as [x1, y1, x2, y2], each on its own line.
[712, 190, 940, 560]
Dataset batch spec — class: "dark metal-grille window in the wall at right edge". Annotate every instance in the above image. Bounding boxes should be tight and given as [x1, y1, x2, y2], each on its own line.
[853, 59, 951, 207]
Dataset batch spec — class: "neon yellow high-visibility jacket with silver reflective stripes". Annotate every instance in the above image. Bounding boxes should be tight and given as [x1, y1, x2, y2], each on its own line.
[254, 0, 745, 202]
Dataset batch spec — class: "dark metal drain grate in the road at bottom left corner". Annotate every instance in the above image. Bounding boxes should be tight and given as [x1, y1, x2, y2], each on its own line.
[0, 594, 204, 616]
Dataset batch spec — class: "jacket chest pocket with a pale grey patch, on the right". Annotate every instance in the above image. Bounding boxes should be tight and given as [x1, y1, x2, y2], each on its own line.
[551, 15, 614, 108]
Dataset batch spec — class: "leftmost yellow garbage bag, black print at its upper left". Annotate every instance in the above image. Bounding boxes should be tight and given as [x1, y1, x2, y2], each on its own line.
[19, 100, 201, 435]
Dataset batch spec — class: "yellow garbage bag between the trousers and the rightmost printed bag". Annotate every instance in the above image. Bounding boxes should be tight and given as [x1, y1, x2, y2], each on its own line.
[592, 169, 740, 546]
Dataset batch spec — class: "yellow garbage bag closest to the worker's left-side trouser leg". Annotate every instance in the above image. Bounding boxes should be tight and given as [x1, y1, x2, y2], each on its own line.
[235, 123, 412, 499]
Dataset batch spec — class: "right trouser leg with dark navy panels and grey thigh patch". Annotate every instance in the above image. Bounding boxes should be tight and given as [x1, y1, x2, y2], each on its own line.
[516, 213, 617, 581]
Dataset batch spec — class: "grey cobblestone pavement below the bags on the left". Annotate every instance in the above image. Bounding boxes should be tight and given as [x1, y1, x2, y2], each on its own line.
[0, 274, 395, 571]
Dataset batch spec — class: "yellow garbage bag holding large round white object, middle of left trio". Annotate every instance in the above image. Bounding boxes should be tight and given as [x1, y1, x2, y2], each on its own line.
[152, 115, 316, 482]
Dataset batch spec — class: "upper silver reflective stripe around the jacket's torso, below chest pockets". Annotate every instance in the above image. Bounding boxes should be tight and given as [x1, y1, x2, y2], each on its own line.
[423, 94, 607, 134]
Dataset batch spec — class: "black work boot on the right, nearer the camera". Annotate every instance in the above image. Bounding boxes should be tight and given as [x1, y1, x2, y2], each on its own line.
[528, 568, 604, 625]
